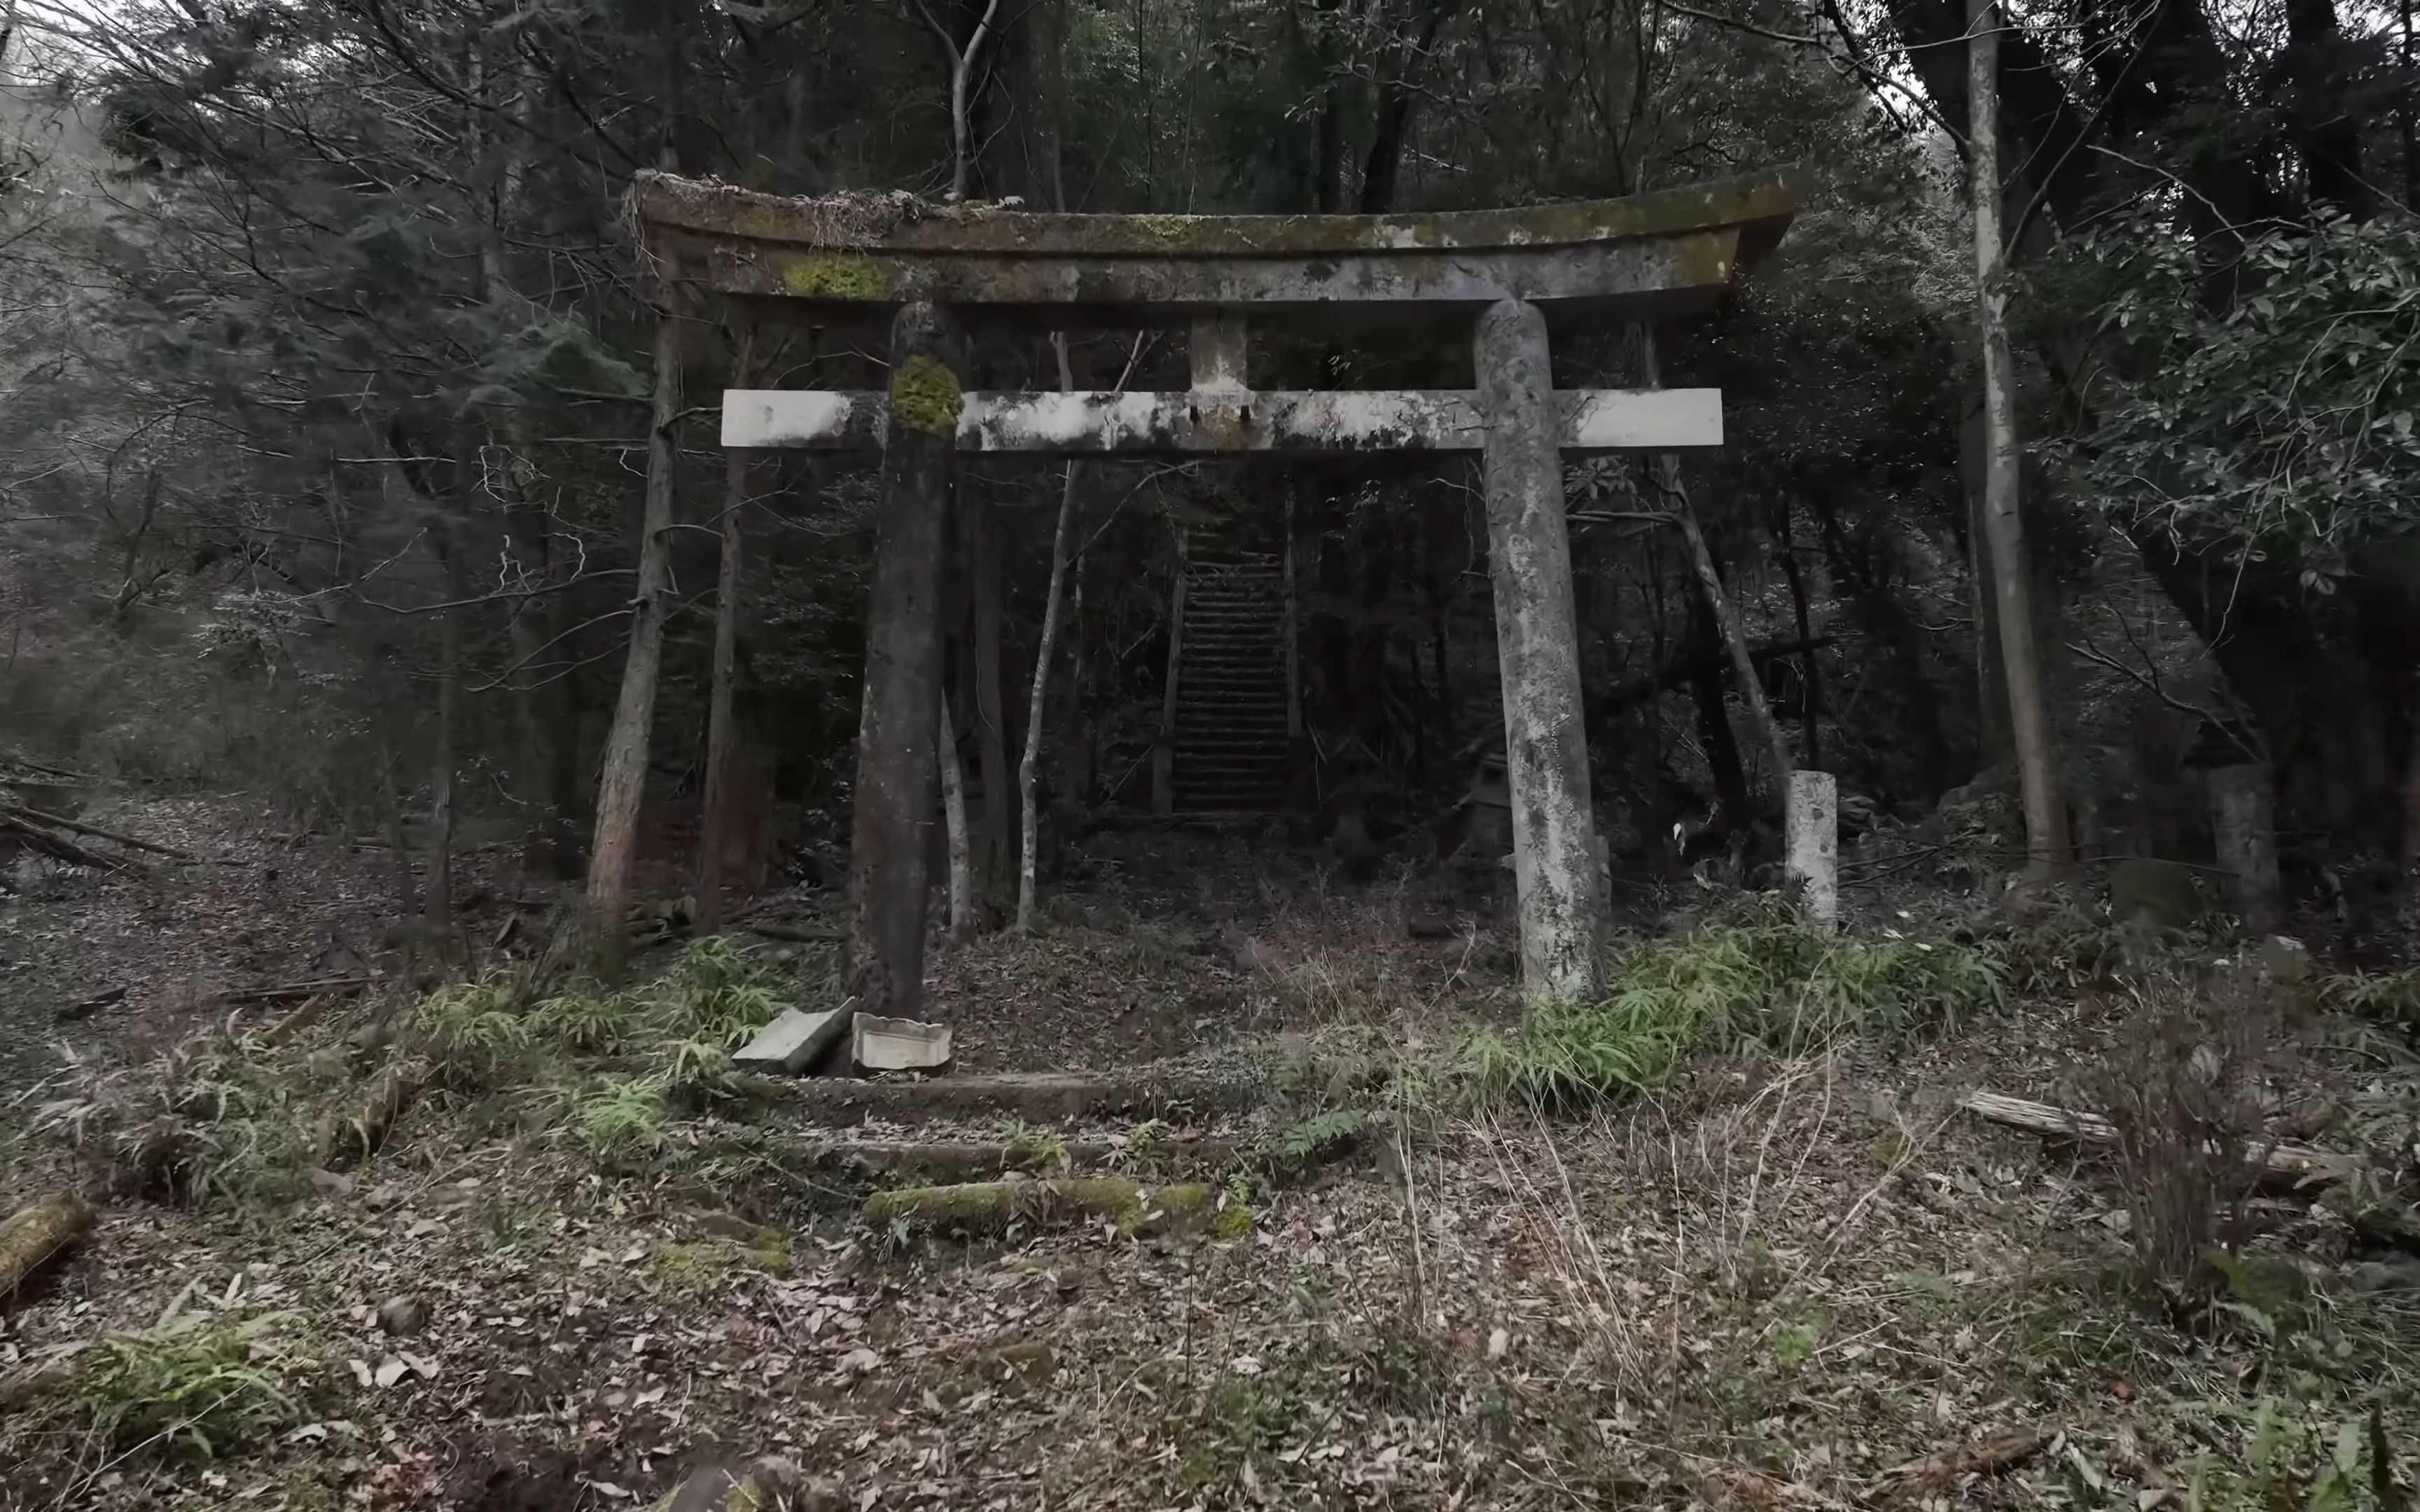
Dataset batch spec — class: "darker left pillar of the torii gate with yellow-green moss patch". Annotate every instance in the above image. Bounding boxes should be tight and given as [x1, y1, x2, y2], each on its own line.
[847, 304, 966, 1018]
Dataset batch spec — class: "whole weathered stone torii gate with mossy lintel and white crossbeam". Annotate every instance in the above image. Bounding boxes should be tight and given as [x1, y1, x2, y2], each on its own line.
[632, 174, 1800, 1011]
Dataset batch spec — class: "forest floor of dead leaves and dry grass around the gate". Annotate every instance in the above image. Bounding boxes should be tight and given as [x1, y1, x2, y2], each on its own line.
[0, 808, 2420, 1512]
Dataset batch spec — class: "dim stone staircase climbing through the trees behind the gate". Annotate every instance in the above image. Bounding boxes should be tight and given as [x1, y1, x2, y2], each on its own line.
[1171, 540, 1290, 816]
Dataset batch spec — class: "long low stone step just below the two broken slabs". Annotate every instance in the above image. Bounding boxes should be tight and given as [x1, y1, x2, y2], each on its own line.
[741, 1067, 1273, 1125]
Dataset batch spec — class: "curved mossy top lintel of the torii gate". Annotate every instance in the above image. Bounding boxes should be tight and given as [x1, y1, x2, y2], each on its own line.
[632, 172, 1803, 322]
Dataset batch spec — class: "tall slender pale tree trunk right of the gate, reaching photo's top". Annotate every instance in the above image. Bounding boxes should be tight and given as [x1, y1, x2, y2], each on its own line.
[1968, 0, 2069, 874]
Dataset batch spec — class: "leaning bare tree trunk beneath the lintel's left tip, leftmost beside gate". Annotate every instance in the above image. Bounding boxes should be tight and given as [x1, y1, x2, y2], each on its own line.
[588, 288, 680, 977]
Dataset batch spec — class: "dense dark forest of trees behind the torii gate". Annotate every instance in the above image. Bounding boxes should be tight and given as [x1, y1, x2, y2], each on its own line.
[5, 5, 2420, 919]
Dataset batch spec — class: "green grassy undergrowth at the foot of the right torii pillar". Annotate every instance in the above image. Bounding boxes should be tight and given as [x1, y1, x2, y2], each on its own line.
[1464, 909, 2006, 1105]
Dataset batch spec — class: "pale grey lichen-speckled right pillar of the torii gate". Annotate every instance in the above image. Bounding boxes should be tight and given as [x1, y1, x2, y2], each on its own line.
[1476, 300, 1604, 994]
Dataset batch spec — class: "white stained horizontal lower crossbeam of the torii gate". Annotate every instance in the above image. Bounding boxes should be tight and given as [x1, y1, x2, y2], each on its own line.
[723, 389, 1723, 457]
